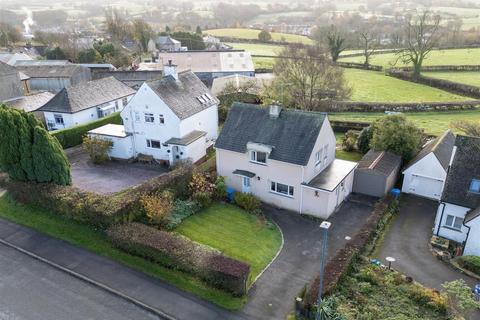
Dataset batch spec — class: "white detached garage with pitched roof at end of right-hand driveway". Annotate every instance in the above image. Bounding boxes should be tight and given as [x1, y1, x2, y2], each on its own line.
[402, 130, 455, 200]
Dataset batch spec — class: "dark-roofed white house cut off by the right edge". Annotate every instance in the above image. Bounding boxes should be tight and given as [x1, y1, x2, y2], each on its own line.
[433, 135, 480, 255]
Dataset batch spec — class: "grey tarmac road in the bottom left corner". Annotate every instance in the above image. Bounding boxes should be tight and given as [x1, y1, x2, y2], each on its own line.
[0, 245, 159, 320]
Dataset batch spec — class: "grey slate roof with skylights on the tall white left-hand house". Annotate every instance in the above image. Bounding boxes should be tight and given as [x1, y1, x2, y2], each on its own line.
[147, 71, 218, 120]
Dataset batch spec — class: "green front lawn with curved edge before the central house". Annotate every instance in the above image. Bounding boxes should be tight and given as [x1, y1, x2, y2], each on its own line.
[175, 204, 282, 285]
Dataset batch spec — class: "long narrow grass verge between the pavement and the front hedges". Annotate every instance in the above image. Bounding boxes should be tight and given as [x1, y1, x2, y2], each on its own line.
[0, 195, 246, 310]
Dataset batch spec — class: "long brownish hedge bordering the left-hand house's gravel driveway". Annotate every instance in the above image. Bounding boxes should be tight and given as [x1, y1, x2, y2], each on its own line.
[6, 166, 192, 229]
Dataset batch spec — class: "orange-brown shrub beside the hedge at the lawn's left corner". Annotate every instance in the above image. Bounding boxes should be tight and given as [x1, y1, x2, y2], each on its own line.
[140, 190, 174, 226]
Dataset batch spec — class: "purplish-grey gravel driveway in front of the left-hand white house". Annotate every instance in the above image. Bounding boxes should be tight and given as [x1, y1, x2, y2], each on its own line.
[65, 146, 167, 194]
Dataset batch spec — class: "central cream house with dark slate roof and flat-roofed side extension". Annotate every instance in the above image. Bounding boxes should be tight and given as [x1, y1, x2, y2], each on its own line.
[215, 102, 357, 219]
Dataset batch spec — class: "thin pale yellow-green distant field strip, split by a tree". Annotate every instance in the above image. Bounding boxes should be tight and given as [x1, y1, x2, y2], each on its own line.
[204, 28, 313, 44]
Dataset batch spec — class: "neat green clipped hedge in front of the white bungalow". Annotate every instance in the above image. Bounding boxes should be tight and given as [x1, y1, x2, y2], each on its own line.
[51, 112, 122, 149]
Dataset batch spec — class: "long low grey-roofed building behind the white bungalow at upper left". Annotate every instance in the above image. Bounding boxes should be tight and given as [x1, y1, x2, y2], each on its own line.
[15, 64, 92, 92]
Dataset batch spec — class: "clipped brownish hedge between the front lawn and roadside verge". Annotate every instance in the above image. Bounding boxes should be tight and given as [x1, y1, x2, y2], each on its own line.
[107, 222, 250, 296]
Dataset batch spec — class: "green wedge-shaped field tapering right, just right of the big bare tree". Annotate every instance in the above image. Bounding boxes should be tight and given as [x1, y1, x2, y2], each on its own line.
[344, 69, 471, 102]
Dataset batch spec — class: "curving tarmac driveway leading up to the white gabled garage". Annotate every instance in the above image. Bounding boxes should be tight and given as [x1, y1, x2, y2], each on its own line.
[379, 195, 476, 290]
